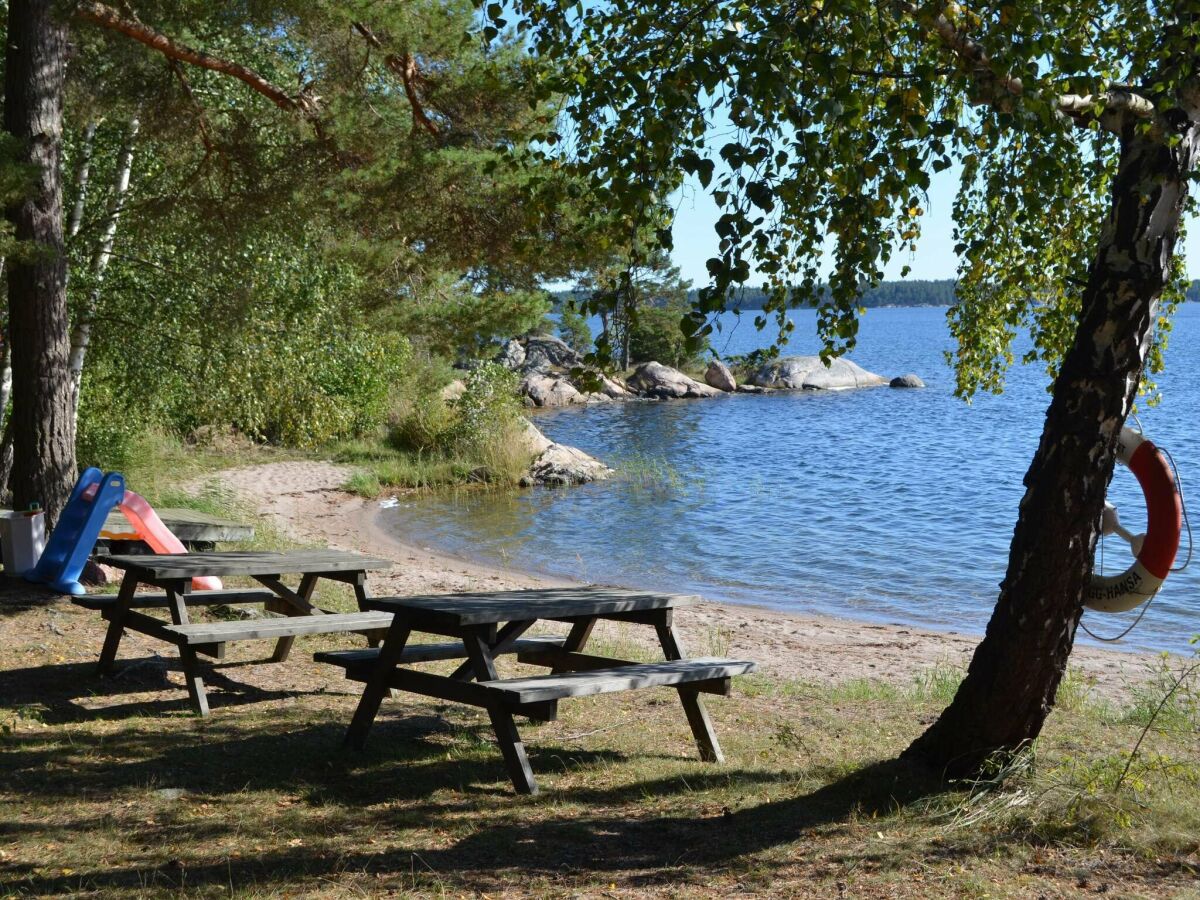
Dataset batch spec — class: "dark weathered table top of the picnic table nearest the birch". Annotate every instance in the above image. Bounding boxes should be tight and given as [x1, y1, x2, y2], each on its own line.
[366, 587, 701, 626]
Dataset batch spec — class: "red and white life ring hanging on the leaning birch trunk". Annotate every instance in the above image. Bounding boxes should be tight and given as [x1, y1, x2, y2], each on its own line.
[1084, 428, 1183, 612]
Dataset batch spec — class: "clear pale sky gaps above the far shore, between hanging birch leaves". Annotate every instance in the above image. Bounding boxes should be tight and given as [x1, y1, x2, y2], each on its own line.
[671, 166, 1200, 287]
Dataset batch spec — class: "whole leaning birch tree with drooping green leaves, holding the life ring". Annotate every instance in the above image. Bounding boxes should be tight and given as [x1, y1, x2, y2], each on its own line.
[485, 0, 1200, 773]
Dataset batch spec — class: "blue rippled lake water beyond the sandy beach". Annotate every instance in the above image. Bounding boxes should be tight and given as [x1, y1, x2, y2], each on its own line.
[385, 304, 1200, 652]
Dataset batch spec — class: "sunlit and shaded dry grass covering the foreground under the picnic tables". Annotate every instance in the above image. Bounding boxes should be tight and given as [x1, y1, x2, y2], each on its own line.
[0, 606, 1200, 896]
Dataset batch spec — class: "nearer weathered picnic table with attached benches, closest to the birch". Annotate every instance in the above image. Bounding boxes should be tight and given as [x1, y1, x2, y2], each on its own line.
[314, 587, 757, 794]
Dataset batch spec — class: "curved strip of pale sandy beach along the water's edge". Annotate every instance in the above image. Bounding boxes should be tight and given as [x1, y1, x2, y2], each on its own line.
[213, 461, 1180, 698]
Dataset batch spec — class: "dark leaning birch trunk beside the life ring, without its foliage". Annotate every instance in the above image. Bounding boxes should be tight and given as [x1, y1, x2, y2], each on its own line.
[905, 124, 1200, 775]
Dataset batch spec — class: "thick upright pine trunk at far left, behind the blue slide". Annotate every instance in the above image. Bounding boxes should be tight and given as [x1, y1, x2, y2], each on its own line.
[4, 0, 76, 524]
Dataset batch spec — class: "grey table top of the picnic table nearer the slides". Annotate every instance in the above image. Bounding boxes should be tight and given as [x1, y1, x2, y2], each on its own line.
[96, 550, 394, 581]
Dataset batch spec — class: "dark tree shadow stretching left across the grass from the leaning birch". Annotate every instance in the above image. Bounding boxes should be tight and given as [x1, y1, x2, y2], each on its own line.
[0, 707, 944, 894]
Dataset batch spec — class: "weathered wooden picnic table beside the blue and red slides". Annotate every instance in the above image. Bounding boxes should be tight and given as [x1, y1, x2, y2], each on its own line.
[81, 550, 392, 715]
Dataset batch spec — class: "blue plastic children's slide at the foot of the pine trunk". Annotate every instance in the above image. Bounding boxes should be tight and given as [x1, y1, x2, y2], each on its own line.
[25, 468, 125, 595]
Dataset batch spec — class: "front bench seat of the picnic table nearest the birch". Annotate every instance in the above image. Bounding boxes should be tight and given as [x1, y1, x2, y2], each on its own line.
[479, 658, 758, 703]
